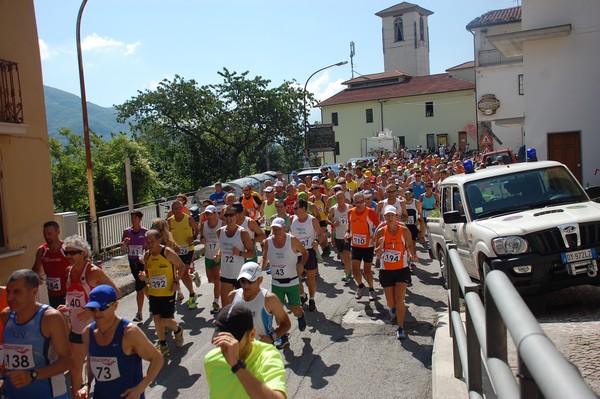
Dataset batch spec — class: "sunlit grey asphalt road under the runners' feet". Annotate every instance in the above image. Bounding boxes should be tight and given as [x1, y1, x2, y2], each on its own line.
[110, 247, 446, 399]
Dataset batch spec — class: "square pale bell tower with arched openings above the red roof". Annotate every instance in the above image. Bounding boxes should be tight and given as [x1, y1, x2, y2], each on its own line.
[375, 1, 433, 76]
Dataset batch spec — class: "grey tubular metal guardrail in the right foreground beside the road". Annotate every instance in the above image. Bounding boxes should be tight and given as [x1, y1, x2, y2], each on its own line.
[446, 243, 596, 399]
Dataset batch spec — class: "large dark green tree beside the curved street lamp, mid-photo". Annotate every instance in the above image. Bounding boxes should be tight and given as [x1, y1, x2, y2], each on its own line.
[116, 69, 312, 191]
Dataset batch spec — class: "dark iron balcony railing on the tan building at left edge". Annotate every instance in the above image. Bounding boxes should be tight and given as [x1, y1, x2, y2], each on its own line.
[0, 59, 23, 123]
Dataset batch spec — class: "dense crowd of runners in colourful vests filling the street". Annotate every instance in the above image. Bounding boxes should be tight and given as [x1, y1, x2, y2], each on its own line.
[0, 154, 476, 398]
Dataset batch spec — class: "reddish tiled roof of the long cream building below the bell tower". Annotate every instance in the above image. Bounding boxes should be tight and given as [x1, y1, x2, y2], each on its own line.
[317, 73, 475, 107]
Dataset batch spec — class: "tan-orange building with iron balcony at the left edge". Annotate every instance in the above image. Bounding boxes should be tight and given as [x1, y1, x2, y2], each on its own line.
[0, 0, 54, 284]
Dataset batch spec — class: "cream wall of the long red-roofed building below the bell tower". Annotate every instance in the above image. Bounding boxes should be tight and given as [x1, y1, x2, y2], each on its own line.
[321, 90, 477, 163]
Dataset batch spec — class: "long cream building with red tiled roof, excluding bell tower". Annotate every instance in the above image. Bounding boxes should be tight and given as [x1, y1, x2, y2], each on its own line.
[319, 71, 477, 163]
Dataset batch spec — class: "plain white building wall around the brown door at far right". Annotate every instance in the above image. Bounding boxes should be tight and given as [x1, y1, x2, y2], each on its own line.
[522, 0, 600, 185]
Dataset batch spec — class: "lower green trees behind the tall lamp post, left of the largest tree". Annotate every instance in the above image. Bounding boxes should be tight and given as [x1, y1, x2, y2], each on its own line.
[50, 129, 161, 215]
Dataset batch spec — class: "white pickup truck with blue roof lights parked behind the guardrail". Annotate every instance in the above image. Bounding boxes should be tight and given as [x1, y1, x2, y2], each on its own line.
[427, 161, 600, 294]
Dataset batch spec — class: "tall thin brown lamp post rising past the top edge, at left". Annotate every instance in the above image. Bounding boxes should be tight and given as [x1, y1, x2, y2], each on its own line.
[76, 0, 100, 253]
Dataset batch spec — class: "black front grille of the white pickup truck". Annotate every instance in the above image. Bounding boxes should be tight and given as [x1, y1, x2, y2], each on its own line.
[525, 222, 600, 255]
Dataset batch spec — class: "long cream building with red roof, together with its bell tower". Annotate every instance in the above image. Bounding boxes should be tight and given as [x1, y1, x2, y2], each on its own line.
[316, 2, 477, 163]
